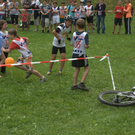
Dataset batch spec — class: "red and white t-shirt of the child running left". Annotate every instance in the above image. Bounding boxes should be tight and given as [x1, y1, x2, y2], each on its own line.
[9, 37, 32, 58]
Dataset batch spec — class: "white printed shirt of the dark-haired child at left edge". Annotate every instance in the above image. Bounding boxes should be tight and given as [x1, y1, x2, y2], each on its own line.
[0, 31, 9, 49]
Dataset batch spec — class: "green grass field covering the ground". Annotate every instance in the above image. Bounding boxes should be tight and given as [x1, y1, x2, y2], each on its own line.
[0, 14, 135, 135]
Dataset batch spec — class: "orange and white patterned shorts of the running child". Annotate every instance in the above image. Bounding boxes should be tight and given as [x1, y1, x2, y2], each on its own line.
[16, 55, 33, 70]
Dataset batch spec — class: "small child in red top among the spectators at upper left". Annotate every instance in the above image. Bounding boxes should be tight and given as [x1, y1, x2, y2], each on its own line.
[21, 9, 28, 31]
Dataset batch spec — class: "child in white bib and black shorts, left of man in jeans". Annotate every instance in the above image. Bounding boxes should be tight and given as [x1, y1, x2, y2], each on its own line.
[85, 0, 94, 34]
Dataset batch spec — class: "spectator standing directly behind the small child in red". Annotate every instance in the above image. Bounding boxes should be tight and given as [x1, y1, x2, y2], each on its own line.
[22, 0, 31, 30]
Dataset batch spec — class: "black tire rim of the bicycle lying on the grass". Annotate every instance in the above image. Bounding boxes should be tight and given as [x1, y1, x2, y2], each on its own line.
[98, 90, 135, 107]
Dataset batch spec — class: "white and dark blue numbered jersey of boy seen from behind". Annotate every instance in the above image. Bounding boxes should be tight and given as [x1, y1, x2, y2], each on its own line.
[70, 31, 89, 56]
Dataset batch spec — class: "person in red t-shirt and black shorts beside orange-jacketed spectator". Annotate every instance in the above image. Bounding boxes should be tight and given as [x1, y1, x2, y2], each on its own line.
[112, 0, 123, 34]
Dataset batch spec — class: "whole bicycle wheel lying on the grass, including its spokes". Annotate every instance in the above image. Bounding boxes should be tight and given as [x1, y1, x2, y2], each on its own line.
[98, 90, 135, 107]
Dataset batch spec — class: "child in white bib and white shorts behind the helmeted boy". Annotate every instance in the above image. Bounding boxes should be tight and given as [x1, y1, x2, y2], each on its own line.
[52, 1, 60, 29]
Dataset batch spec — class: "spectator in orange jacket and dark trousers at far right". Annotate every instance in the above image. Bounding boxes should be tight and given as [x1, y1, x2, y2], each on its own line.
[124, 0, 132, 34]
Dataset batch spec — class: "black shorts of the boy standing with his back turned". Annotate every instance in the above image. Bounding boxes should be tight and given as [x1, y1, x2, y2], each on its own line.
[72, 53, 89, 68]
